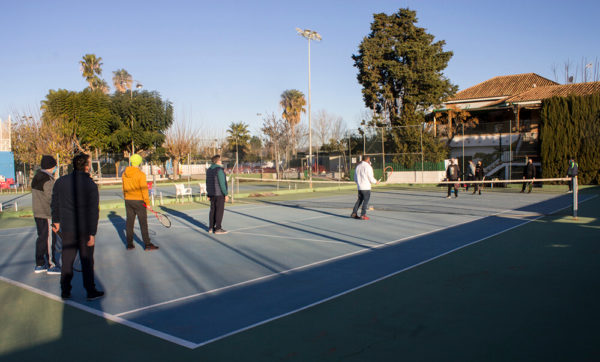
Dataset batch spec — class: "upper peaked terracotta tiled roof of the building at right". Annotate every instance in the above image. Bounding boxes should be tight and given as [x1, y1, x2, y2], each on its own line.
[448, 73, 558, 101]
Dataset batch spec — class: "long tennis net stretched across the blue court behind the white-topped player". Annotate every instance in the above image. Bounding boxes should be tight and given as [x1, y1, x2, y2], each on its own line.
[234, 177, 578, 217]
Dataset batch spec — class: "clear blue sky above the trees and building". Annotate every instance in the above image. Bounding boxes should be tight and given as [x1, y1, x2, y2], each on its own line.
[0, 0, 600, 133]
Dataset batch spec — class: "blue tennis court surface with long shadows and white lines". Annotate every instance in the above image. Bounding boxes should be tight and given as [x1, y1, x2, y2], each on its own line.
[0, 190, 590, 348]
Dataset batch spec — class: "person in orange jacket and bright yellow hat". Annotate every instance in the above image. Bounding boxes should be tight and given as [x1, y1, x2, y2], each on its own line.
[122, 154, 158, 251]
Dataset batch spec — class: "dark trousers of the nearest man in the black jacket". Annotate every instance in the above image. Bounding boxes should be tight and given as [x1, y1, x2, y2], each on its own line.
[60, 231, 96, 293]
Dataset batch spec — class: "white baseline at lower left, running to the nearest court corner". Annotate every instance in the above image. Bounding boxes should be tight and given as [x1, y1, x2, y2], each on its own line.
[0, 276, 197, 349]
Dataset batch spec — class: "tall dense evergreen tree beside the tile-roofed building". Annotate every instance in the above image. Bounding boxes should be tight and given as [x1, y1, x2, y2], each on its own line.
[352, 9, 457, 161]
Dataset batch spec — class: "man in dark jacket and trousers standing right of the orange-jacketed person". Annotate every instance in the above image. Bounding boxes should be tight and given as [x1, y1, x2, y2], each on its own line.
[206, 155, 229, 234]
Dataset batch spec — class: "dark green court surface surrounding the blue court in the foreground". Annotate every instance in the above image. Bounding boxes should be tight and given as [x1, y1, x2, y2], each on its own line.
[0, 188, 600, 361]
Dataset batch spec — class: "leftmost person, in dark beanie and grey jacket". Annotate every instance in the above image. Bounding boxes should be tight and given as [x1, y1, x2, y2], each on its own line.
[31, 155, 61, 274]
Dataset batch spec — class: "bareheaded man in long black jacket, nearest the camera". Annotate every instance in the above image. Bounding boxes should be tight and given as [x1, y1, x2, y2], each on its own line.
[51, 153, 104, 300]
